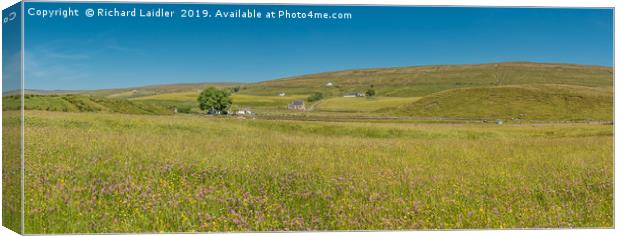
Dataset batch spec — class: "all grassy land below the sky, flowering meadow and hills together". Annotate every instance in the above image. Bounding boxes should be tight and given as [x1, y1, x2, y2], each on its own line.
[9, 62, 614, 234]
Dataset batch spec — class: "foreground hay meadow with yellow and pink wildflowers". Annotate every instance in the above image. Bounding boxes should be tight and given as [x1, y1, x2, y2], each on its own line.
[25, 111, 613, 233]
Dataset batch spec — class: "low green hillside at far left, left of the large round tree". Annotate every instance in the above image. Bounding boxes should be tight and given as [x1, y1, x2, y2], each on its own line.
[3, 94, 173, 115]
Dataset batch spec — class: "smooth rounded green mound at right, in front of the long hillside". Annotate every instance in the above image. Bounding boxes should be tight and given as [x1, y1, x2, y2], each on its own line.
[396, 85, 613, 121]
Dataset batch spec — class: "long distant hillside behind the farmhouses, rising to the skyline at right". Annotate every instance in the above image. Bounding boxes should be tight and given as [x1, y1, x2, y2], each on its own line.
[241, 62, 613, 97]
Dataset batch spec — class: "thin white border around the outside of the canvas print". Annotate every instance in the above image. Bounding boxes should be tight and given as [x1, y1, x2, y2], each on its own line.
[0, 0, 620, 236]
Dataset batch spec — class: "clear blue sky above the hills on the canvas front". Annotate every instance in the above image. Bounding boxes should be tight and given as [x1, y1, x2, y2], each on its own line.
[25, 3, 613, 90]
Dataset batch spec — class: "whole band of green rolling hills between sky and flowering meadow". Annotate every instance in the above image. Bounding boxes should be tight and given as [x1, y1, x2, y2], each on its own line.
[5, 62, 613, 121]
